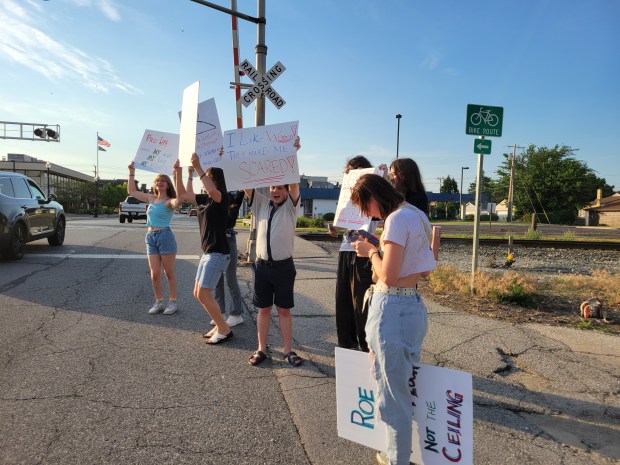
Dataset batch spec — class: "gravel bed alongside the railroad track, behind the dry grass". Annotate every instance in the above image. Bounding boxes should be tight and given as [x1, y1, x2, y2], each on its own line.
[314, 241, 620, 275]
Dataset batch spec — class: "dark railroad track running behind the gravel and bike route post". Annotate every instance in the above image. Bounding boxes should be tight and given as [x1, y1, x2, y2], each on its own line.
[298, 233, 620, 250]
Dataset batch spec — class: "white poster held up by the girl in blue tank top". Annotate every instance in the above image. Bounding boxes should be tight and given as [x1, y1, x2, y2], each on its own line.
[133, 129, 179, 176]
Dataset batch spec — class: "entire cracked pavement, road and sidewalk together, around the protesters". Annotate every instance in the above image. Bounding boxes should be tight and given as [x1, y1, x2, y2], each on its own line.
[0, 217, 620, 465]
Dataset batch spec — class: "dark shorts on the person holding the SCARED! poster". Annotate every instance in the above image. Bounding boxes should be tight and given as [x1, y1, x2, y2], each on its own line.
[252, 258, 297, 308]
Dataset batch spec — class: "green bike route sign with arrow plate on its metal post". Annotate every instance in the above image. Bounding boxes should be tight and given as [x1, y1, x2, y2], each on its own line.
[465, 104, 504, 295]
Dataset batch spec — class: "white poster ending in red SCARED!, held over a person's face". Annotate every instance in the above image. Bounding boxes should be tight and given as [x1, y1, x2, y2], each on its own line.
[220, 121, 299, 190]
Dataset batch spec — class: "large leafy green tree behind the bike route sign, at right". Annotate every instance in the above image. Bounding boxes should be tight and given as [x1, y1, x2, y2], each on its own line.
[494, 144, 613, 224]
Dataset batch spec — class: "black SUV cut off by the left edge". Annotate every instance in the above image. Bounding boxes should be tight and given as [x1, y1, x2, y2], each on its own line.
[0, 171, 66, 260]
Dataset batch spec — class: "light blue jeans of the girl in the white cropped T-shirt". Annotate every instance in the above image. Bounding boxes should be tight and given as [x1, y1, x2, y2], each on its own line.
[366, 286, 428, 465]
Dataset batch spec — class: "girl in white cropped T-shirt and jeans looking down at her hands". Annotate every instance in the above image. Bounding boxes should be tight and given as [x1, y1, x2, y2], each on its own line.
[351, 174, 435, 465]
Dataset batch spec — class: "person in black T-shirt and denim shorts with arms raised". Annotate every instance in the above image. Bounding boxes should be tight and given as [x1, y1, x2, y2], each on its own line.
[174, 153, 233, 344]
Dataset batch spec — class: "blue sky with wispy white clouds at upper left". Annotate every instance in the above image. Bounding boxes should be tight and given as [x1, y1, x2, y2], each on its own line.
[0, 0, 620, 192]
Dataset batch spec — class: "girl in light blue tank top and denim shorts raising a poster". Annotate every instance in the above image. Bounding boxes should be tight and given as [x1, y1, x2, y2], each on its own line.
[127, 162, 181, 315]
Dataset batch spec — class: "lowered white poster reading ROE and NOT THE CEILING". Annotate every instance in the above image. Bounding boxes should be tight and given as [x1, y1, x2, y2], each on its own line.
[336, 347, 474, 465]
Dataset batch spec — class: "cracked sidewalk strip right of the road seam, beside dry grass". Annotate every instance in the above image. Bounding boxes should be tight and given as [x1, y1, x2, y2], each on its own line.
[238, 232, 620, 465]
